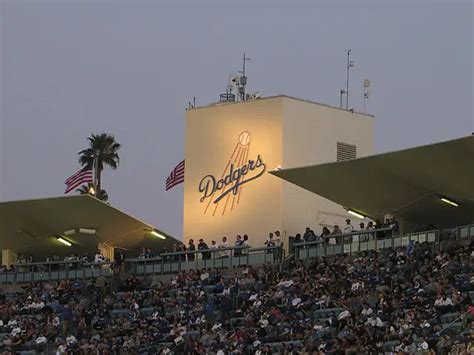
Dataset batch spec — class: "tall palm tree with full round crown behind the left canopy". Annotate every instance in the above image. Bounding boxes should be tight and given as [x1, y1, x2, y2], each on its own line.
[78, 133, 120, 198]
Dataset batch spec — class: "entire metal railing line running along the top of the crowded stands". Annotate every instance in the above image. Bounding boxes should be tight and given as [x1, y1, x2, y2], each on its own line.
[0, 224, 474, 284]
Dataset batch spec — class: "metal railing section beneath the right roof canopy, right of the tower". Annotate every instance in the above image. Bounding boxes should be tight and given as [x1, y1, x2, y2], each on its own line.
[293, 228, 439, 259]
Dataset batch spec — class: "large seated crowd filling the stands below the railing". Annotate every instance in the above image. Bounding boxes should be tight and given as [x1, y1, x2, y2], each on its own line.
[0, 236, 474, 355]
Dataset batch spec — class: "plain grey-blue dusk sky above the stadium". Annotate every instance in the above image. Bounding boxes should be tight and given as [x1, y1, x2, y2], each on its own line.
[0, 0, 474, 238]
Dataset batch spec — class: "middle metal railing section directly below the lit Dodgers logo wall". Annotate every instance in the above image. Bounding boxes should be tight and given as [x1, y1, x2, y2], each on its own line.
[126, 247, 285, 275]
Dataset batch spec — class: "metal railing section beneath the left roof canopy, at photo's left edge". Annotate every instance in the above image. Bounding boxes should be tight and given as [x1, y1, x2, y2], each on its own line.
[0, 260, 113, 283]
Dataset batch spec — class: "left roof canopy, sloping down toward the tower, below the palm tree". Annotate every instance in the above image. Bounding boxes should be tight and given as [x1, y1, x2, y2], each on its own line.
[0, 195, 176, 255]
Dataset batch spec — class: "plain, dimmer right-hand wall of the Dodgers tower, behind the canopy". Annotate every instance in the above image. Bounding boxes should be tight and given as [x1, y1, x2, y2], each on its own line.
[282, 98, 373, 243]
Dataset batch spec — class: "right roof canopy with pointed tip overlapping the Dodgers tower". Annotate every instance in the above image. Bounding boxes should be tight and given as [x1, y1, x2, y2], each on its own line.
[271, 136, 474, 228]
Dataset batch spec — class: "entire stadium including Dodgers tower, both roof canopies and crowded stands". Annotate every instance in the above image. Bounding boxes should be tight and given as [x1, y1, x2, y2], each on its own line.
[0, 96, 474, 355]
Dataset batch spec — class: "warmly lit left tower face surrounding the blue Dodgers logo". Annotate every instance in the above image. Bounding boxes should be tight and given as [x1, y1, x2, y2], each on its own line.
[183, 99, 282, 246]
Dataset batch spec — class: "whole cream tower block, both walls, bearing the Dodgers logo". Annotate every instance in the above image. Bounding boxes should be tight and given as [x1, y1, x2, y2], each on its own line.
[183, 96, 372, 246]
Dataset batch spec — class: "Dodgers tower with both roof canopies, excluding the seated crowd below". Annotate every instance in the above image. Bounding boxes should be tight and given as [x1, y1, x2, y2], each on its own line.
[0, 95, 474, 265]
